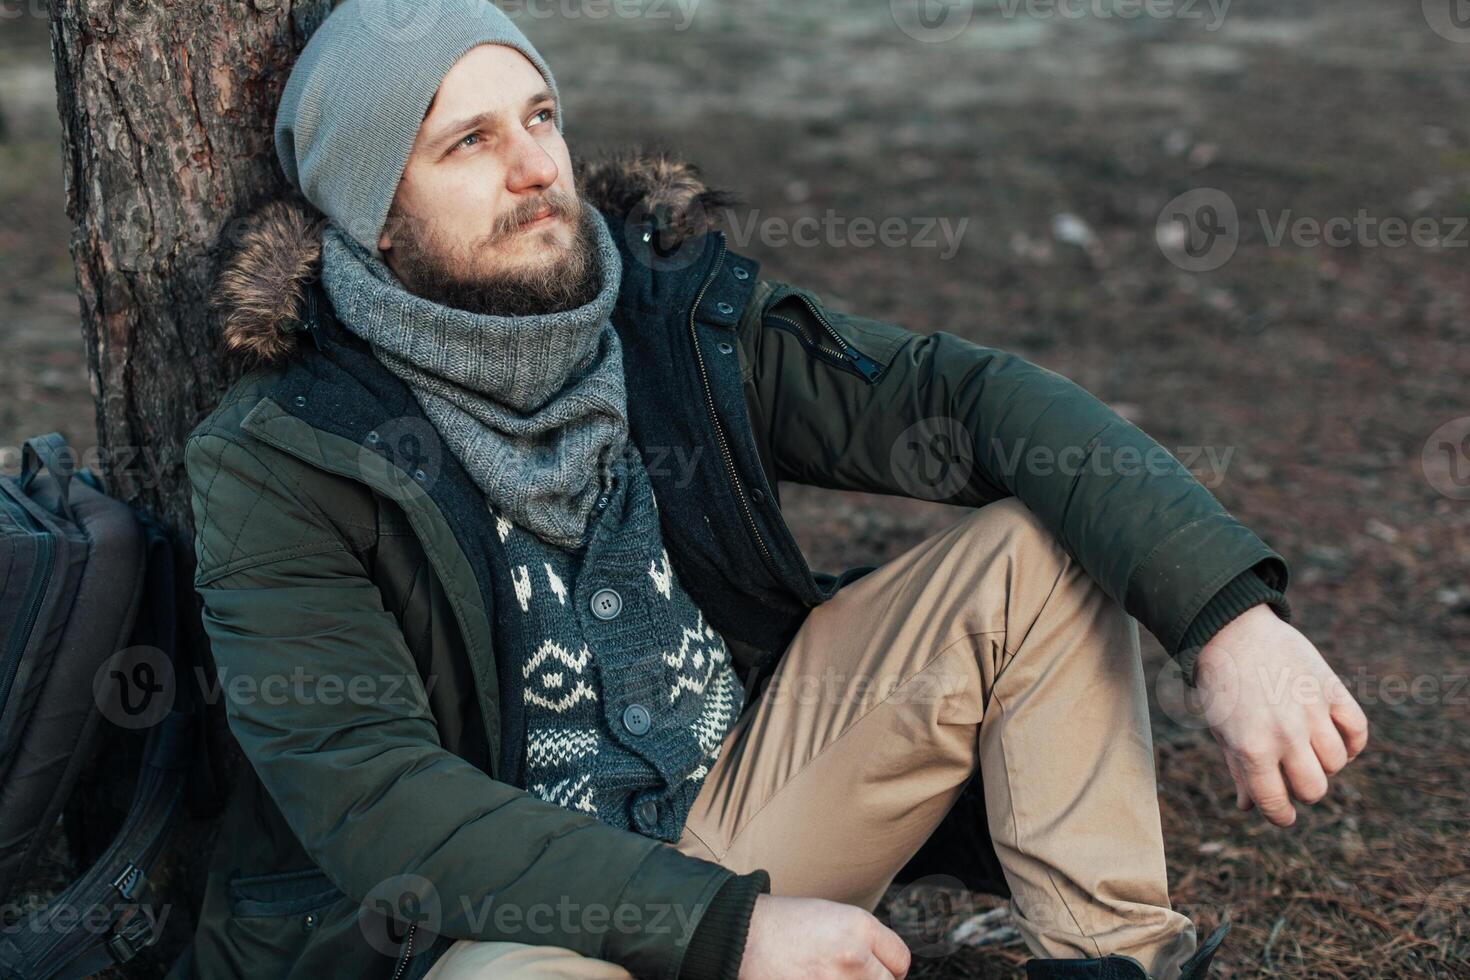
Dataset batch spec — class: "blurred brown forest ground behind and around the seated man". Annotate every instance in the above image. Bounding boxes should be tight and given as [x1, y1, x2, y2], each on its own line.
[0, 0, 1470, 977]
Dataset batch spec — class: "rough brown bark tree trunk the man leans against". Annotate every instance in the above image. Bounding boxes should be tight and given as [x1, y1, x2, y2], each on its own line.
[50, 0, 332, 977]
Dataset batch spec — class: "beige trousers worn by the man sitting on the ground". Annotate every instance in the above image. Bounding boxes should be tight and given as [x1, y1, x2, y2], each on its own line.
[429, 498, 1195, 980]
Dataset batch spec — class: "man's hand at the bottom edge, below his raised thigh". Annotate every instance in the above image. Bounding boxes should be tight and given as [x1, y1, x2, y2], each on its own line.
[739, 895, 910, 980]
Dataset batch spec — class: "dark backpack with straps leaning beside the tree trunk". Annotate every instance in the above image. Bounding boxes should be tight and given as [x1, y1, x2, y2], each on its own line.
[0, 432, 196, 980]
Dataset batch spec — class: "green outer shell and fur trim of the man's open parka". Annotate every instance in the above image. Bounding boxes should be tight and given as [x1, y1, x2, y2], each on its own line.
[175, 151, 1286, 980]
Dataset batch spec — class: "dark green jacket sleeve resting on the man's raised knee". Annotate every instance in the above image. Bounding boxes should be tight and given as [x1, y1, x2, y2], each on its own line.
[739, 281, 1288, 683]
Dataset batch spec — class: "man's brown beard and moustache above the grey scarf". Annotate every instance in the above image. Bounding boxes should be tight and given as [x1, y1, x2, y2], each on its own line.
[392, 191, 603, 316]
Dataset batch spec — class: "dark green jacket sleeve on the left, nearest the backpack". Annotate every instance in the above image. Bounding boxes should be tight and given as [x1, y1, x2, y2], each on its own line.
[185, 435, 769, 980]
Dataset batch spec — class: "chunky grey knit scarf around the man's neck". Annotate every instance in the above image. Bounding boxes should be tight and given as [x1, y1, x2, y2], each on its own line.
[322, 209, 628, 550]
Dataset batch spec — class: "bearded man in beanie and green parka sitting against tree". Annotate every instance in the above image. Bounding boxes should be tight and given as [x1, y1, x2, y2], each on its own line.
[173, 0, 1367, 980]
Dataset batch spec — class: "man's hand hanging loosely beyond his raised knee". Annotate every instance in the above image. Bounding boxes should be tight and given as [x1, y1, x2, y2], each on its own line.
[1195, 605, 1369, 827]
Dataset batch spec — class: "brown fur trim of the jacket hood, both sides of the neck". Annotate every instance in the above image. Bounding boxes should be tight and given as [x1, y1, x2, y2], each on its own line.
[212, 150, 735, 364]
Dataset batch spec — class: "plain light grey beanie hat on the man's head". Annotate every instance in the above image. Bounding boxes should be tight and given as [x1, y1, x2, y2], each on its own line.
[275, 0, 562, 257]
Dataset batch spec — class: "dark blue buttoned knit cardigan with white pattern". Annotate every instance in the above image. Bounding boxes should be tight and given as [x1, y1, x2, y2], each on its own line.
[490, 444, 745, 843]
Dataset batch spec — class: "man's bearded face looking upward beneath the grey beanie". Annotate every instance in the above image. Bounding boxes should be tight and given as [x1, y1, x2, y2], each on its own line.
[378, 44, 601, 316]
